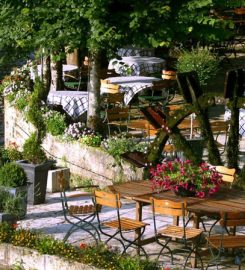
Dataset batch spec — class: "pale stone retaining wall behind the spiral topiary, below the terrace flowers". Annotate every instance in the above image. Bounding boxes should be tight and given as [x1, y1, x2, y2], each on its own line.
[4, 100, 144, 187]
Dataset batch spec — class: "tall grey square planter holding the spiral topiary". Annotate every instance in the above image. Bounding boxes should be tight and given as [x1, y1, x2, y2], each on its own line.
[17, 160, 53, 205]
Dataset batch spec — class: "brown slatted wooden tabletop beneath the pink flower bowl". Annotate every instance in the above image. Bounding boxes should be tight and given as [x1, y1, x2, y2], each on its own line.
[110, 180, 245, 214]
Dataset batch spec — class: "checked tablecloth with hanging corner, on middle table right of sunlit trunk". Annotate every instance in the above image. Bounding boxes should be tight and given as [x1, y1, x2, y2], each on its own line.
[100, 76, 161, 105]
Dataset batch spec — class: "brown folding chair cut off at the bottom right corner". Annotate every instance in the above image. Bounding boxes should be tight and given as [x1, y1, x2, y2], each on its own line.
[206, 212, 245, 269]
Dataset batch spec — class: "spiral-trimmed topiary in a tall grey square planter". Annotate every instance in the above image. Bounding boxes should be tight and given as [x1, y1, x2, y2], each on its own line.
[18, 77, 53, 204]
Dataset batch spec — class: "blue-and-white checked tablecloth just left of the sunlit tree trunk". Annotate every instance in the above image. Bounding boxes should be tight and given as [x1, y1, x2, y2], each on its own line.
[47, 91, 88, 118]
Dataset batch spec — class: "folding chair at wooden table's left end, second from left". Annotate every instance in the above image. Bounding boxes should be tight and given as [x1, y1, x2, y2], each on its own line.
[95, 190, 148, 257]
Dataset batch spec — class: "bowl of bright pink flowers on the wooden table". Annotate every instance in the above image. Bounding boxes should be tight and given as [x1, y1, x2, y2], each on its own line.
[150, 159, 222, 198]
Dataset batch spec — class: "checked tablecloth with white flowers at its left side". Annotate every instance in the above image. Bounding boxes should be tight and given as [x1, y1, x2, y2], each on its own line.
[108, 56, 166, 76]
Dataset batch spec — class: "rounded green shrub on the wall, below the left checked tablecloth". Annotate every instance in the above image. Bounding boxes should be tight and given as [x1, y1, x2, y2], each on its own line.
[44, 111, 66, 136]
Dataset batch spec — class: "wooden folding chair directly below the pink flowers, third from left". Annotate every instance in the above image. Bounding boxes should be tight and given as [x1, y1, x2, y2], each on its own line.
[151, 198, 203, 269]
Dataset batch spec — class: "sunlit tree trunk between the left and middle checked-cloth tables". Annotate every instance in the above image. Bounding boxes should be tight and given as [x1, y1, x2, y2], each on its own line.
[87, 52, 100, 131]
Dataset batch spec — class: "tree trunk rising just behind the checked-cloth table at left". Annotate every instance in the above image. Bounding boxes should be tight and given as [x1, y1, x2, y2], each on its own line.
[50, 55, 64, 91]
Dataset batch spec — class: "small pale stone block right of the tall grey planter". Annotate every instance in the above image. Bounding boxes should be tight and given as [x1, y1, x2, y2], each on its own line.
[47, 167, 70, 193]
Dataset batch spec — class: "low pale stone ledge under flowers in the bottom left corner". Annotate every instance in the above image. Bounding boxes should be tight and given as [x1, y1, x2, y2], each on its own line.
[0, 244, 99, 270]
